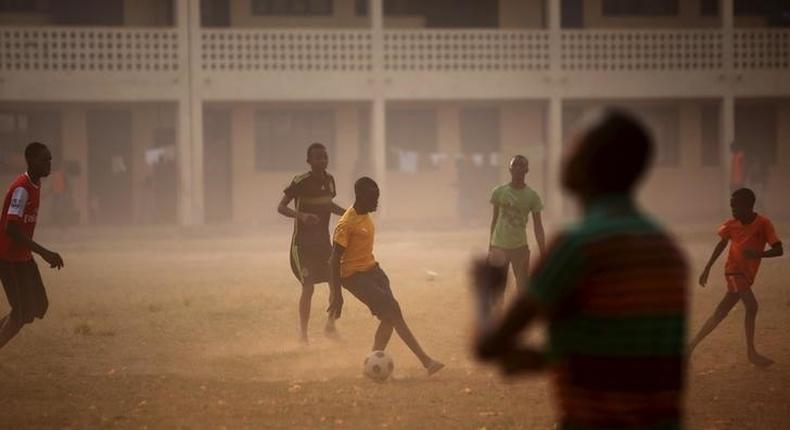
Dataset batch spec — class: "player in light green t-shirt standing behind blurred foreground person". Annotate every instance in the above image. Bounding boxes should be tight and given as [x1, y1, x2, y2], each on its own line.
[489, 155, 546, 301]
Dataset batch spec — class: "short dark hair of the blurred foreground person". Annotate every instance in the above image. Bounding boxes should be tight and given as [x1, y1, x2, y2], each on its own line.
[578, 108, 653, 192]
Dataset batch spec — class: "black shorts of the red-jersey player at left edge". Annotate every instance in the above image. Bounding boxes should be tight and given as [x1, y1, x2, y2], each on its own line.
[0, 260, 49, 324]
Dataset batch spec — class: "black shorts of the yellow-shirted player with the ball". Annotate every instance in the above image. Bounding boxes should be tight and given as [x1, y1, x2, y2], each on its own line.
[341, 264, 401, 322]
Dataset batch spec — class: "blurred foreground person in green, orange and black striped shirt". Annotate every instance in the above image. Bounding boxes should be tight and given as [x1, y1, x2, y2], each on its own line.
[473, 110, 688, 430]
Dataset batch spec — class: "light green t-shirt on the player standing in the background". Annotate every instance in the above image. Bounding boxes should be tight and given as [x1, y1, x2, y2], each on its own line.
[491, 184, 543, 249]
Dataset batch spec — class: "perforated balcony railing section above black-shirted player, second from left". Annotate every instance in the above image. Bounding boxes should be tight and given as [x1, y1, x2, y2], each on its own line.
[201, 30, 373, 72]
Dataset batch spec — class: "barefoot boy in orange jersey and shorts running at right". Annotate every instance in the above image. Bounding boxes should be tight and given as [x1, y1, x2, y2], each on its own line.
[689, 188, 784, 367]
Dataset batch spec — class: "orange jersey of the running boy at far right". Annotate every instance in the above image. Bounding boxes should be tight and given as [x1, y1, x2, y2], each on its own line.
[719, 215, 779, 285]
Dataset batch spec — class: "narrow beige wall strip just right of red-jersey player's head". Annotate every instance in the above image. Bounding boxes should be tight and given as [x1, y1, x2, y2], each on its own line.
[63, 105, 88, 225]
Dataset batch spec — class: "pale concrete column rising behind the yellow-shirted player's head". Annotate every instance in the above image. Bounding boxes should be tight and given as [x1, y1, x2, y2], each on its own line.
[370, 0, 387, 207]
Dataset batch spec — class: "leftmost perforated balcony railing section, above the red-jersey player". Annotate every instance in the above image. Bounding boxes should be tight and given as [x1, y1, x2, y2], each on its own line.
[0, 27, 179, 72]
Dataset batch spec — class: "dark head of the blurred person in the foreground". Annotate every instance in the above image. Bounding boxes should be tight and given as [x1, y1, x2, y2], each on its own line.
[562, 109, 653, 201]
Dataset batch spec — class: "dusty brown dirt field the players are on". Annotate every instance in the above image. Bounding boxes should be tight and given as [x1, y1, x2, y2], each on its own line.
[0, 223, 790, 429]
